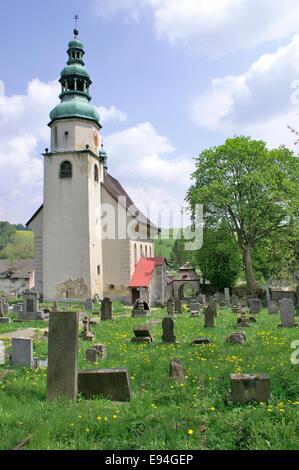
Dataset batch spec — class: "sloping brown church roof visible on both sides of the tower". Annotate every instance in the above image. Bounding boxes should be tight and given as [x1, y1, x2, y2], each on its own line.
[26, 173, 159, 230]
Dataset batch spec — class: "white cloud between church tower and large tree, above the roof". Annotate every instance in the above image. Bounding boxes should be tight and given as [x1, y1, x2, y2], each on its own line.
[105, 122, 194, 226]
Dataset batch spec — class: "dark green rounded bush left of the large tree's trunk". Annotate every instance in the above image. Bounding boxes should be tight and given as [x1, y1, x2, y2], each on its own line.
[194, 222, 242, 290]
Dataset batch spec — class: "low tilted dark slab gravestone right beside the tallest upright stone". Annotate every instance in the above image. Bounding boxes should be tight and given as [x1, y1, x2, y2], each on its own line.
[78, 369, 131, 402]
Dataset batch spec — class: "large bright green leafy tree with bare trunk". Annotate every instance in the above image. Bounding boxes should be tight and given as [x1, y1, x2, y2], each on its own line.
[186, 136, 299, 292]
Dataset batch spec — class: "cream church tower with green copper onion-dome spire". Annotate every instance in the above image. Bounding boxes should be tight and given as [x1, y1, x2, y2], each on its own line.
[43, 29, 104, 300]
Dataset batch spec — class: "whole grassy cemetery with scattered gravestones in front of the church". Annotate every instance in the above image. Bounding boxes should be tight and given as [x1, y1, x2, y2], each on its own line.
[0, 293, 299, 450]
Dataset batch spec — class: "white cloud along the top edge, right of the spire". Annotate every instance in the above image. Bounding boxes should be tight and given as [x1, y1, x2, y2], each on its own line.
[94, 0, 299, 57]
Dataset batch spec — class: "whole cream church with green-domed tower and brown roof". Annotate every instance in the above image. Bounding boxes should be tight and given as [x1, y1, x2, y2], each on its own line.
[27, 29, 165, 303]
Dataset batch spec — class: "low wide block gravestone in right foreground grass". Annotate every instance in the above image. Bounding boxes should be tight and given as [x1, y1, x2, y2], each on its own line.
[231, 374, 271, 403]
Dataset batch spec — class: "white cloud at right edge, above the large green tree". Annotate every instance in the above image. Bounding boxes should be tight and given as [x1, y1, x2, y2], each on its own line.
[192, 35, 299, 146]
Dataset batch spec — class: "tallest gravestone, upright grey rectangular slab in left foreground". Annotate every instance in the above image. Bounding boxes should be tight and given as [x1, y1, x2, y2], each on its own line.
[47, 312, 79, 400]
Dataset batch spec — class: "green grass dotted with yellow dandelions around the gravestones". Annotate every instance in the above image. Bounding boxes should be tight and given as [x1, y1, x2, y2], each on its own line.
[0, 304, 299, 450]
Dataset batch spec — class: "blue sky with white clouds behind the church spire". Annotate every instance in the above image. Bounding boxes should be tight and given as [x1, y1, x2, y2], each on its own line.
[0, 0, 299, 226]
